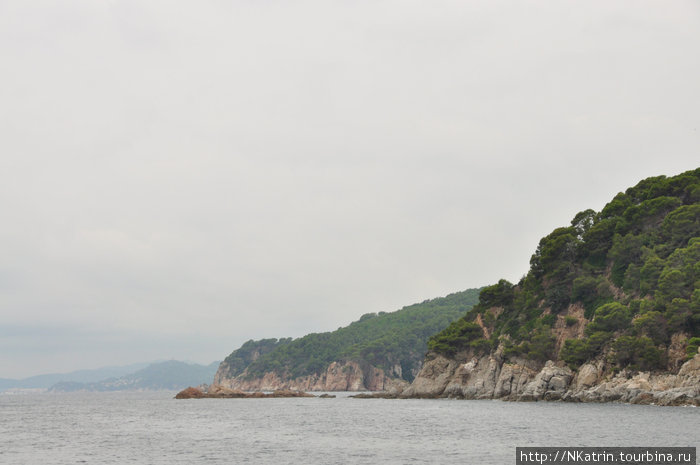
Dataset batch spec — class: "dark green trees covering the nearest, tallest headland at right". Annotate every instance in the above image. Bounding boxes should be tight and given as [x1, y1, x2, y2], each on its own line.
[428, 168, 700, 370]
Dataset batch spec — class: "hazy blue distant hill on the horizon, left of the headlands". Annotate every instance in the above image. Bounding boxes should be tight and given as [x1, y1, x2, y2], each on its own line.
[50, 360, 219, 392]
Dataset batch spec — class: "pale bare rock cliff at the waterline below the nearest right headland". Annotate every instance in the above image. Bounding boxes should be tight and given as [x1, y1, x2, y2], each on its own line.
[401, 346, 700, 406]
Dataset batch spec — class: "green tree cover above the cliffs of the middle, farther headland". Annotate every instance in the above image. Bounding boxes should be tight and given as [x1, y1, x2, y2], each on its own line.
[224, 289, 479, 381]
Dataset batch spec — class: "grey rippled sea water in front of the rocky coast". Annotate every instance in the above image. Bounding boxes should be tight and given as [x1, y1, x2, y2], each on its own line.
[0, 392, 700, 465]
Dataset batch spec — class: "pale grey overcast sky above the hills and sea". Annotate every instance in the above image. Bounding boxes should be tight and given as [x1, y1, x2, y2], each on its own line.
[0, 0, 700, 378]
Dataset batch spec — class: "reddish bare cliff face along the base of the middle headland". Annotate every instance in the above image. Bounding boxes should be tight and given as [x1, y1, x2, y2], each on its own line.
[214, 361, 408, 392]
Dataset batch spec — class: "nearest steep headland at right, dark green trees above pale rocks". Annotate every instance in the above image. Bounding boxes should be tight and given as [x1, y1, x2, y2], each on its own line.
[403, 169, 700, 404]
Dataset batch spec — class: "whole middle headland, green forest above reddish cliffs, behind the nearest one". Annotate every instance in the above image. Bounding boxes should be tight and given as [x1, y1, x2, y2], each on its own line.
[214, 289, 479, 390]
